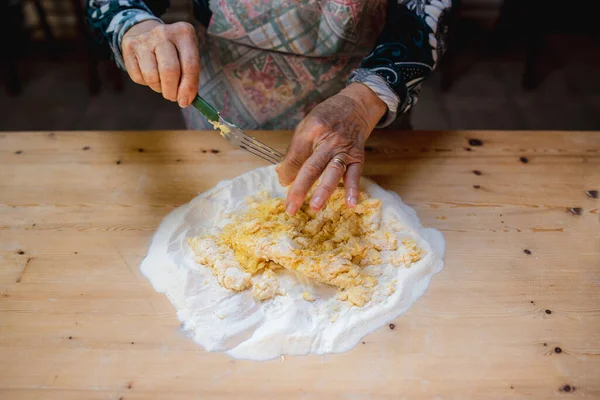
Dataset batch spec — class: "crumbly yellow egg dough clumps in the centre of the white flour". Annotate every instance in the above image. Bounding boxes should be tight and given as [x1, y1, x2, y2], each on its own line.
[189, 188, 424, 307]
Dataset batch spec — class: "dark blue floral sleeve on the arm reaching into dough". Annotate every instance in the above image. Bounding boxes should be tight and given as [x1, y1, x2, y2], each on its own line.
[348, 0, 452, 127]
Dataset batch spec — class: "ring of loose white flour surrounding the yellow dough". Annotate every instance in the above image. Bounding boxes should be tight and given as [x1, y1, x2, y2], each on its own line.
[141, 167, 444, 360]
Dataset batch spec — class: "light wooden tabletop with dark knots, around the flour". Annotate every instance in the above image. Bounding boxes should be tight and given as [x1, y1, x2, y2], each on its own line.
[0, 132, 600, 400]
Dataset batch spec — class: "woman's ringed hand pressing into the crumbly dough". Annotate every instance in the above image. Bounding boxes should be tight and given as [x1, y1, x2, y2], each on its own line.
[276, 83, 387, 215]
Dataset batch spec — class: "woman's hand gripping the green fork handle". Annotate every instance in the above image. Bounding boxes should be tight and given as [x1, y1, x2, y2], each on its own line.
[121, 21, 200, 107]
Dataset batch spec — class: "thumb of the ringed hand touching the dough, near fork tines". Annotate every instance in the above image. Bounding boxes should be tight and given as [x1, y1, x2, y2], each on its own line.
[275, 119, 327, 186]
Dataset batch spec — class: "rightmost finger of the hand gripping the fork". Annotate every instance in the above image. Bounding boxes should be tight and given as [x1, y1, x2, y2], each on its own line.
[175, 34, 200, 107]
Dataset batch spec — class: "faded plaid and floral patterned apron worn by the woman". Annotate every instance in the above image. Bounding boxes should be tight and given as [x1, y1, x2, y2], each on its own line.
[183, 0, 386, 129]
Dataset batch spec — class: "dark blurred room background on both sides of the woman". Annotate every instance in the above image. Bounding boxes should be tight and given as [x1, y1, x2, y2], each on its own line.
[0, 0, 600, 131]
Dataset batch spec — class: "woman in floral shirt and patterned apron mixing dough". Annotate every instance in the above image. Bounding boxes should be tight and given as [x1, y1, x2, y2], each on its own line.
[87, 0, 451, 214]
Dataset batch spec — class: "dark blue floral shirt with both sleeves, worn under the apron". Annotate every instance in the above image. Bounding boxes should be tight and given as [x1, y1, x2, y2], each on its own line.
[86, 0, 452, 127]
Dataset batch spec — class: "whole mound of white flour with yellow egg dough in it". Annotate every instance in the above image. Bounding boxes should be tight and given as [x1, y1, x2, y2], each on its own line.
[141, 167, 444, 360]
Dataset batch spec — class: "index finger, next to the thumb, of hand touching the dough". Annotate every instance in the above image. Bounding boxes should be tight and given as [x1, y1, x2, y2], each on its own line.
[285, 147, 331, 215]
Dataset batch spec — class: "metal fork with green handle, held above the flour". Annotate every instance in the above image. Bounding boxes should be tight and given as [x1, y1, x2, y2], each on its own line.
[192, 96, 283, 164]
